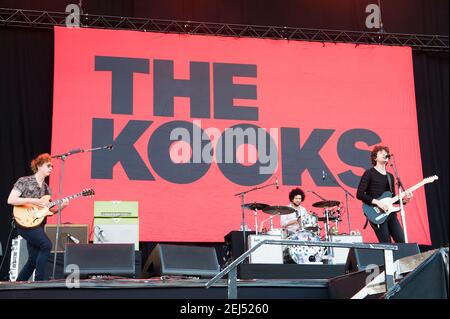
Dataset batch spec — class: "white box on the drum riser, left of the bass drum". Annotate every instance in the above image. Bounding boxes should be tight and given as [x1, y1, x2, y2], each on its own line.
[248, 235, 283, 264]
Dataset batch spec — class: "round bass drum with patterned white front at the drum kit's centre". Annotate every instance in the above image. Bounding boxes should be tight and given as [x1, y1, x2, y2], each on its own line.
[287, 231, 325, 264]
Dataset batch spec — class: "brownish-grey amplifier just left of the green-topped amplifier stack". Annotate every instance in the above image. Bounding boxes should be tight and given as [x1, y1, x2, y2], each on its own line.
[45, 224, 89, 253]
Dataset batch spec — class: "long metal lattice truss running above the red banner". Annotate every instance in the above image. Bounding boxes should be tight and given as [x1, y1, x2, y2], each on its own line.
[0, 8, 449, 52]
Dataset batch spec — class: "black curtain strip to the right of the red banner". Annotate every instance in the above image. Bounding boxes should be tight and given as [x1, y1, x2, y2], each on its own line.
[409, 52, 449, 250]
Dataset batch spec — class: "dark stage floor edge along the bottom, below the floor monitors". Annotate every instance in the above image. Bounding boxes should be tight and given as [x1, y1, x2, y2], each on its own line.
[0, 276, 329, 299]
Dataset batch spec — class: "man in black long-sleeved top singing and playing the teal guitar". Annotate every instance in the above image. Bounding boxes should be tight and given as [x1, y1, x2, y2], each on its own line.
[356, 145, 412, 243]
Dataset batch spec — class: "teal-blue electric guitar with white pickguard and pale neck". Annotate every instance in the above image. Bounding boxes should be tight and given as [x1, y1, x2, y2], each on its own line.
[363, 175, 438, 225]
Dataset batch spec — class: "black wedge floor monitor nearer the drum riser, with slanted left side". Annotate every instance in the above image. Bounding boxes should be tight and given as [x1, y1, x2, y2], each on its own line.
[143, 244, 220, 278]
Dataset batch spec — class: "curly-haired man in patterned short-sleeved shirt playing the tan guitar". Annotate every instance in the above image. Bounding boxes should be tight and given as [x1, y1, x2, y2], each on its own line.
[8, 153, 69, 281]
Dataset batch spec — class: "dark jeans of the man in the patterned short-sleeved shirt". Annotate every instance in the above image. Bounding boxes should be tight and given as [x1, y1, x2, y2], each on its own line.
[17, 225, 52, 281]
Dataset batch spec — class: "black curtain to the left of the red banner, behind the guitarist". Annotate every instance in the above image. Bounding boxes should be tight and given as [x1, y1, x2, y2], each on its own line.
[0, 27, 53, 280]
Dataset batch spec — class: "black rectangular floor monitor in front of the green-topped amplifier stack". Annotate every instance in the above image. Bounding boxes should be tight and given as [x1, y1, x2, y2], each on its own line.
[64, 244, 135, 278]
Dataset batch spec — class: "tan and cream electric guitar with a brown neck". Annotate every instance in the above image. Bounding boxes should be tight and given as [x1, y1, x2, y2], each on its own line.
[13, 188, 95, 228]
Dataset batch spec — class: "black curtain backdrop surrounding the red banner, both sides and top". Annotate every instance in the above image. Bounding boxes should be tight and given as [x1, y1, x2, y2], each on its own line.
[0, 0, 449, 280]
